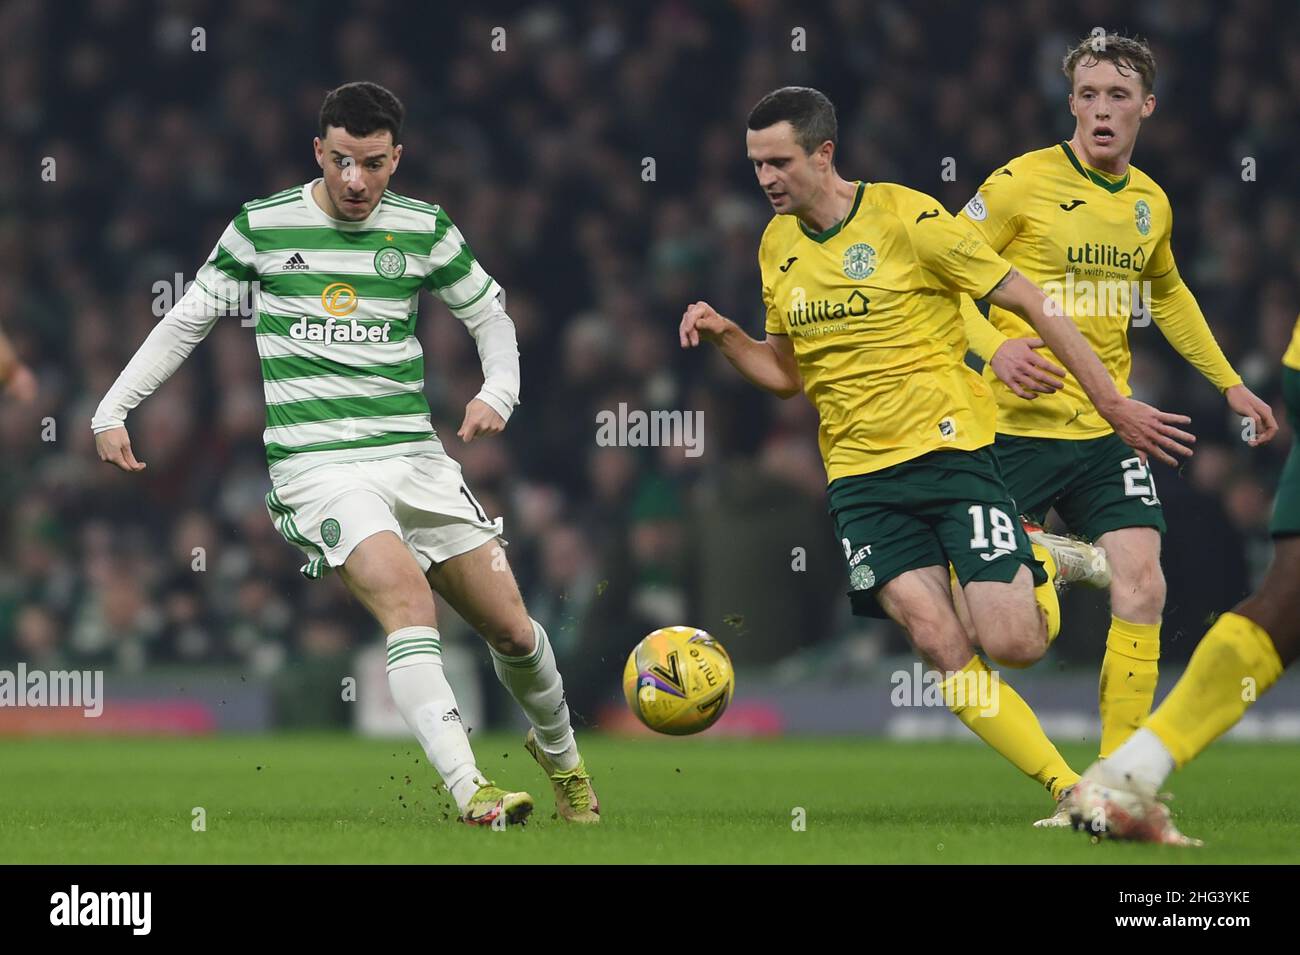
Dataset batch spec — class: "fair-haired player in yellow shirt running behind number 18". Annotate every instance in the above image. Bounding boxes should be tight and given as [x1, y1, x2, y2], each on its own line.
[958, 35, 1277, 779]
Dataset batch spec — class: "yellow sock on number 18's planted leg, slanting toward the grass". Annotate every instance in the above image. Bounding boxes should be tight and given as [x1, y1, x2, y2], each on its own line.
[941, 656, 1079, 799]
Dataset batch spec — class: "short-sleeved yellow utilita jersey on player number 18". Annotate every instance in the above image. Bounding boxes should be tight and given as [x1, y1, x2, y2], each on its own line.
[758, 182, 1010, 481]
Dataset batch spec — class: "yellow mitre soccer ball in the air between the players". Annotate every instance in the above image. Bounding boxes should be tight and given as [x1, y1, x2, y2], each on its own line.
[623, 626, 736, 737]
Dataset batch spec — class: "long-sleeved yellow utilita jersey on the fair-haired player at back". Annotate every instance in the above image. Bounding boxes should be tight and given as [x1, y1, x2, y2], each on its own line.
[958, 143, 1242, 439]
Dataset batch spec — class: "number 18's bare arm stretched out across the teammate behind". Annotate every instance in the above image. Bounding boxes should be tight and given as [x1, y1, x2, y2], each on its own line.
[987, 269, 1196, 466]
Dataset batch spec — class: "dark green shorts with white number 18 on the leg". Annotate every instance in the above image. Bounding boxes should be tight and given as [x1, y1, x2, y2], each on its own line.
[827, 447, 1048, 617]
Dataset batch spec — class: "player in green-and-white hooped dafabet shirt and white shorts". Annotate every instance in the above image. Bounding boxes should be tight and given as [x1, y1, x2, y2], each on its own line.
[92, 83, 599, 825]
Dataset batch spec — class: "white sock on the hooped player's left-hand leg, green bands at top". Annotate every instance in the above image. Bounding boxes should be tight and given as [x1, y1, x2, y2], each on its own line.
[387, 626, 485, 812]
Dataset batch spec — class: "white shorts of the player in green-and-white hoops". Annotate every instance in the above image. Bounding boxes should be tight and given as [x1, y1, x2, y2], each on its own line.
[267, 452, 502, 579]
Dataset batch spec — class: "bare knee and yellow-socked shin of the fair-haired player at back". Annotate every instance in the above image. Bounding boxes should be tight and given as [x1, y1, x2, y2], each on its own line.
[1097, 528, 1165, 756]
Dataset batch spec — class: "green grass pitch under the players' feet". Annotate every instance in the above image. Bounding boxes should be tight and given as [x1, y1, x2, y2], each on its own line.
[0, 733, 1300, 863]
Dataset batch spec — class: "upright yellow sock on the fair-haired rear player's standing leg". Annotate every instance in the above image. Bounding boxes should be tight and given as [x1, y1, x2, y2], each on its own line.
[1097, 617, 1160, 759]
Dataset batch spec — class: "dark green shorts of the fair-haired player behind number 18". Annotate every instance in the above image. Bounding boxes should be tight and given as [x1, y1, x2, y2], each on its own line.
[993, 434, 1165, 541]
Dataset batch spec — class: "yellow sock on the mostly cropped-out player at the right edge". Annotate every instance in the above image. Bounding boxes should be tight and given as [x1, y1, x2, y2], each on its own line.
[1147, 613, 1283, 767]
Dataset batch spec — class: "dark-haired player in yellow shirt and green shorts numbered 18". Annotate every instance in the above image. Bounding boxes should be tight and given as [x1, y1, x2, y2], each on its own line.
[680, 87, 1192, 796]
